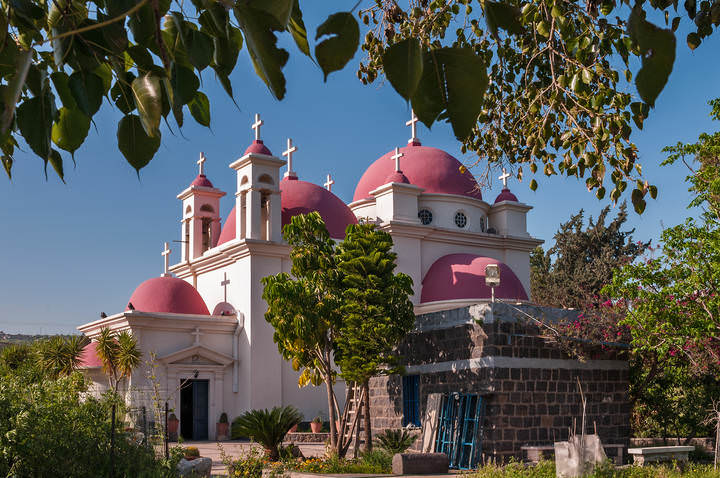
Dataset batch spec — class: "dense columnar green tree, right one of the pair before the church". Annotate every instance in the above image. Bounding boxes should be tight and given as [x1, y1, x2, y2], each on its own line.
[335, 223, 415, 450]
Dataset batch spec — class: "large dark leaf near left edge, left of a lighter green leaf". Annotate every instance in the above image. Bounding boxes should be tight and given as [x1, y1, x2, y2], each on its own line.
[17, 92, 55, 161]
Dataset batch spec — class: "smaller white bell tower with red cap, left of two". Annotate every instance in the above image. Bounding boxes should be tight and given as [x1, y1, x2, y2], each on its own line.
[178, 153, 225, 262]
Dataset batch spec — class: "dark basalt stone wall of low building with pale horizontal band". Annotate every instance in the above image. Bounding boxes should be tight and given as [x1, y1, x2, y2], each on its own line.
[370, 304, 630, 461]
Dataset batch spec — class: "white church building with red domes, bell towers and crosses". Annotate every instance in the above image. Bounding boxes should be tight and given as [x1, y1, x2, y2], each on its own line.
[78, 115, 584, 452]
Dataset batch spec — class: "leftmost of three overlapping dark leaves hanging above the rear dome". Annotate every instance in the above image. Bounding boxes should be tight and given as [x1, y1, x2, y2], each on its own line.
[383, 38, 423, 100]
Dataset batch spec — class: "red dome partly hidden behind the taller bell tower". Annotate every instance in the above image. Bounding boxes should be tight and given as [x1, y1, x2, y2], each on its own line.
[217, 178, 357, 246]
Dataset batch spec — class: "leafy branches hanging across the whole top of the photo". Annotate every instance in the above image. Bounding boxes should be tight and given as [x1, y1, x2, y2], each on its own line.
[0, 0, 720, 211]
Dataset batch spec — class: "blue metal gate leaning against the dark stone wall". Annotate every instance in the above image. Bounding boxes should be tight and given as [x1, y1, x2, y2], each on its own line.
[435, 393, 484, 470]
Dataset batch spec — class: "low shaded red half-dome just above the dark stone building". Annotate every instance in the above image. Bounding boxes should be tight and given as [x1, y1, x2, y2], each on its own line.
[420, 254, 528, 303]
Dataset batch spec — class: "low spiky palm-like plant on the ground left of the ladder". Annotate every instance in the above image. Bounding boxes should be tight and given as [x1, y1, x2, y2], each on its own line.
[233, 406, 303, 461]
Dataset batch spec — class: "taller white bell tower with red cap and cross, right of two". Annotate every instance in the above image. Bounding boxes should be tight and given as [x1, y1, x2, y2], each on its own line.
[230, 114, 285, 242]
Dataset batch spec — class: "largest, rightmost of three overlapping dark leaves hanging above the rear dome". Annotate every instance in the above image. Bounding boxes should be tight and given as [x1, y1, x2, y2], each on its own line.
[438, 48, 488, 141]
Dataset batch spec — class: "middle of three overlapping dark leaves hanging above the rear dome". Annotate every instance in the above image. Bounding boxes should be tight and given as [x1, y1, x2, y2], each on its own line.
[411, 50, 445, 128]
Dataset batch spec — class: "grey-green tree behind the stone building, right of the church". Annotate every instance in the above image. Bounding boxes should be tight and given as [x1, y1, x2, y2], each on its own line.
[530, 203, 650, 310]
